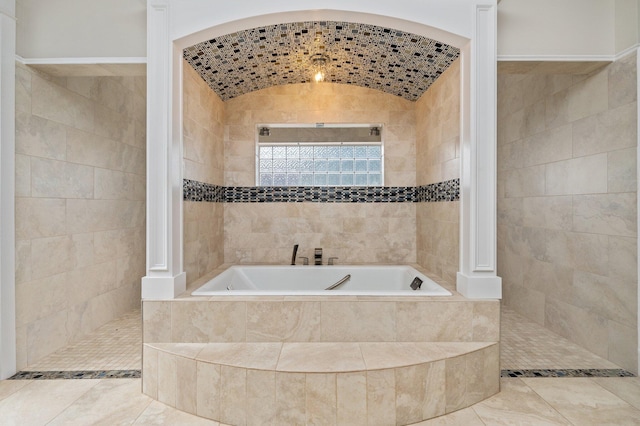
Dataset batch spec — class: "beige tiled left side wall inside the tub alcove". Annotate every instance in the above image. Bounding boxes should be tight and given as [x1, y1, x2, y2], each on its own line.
[183, 61, 225, 283]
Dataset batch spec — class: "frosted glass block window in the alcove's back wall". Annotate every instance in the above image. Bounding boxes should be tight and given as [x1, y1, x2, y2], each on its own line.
[256, 142, 384, 186]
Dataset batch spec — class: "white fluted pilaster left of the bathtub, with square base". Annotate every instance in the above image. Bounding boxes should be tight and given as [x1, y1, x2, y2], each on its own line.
[142, 0, 186, 299]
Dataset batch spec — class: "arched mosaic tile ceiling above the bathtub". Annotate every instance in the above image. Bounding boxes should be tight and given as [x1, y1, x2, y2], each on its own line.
[184, 21, 460, 101]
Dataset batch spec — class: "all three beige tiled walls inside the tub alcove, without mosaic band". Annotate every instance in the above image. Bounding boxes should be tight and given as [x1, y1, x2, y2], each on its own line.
[179, 60, 460, 283]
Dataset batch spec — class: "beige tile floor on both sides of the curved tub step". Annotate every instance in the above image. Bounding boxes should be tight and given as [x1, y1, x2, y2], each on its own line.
[0, 309, 640, 426]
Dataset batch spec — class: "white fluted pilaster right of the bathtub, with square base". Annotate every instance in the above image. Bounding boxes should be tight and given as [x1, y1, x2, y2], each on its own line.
[456, 3, 502, 298]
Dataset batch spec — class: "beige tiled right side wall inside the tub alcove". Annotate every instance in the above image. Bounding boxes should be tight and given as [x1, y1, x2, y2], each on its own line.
[416, 60, 460, 283]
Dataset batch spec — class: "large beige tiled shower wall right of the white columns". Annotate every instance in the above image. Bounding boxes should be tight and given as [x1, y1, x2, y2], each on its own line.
[498, 55, 638, 371]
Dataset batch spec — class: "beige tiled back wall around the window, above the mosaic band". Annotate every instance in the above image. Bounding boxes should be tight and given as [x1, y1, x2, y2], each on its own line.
[224, 83, 416, 186]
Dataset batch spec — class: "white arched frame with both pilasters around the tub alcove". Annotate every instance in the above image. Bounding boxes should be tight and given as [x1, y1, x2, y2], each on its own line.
[143, 4, 500, 298]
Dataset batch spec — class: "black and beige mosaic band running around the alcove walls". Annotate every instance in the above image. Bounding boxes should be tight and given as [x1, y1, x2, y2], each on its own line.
[183, 179, 460, 203]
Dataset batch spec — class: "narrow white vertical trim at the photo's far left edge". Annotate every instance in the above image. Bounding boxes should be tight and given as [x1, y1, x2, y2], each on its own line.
[0, 6, 16, 379]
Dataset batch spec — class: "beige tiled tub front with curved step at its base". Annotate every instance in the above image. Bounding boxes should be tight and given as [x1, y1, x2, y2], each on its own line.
[143, 270, 500, 424]
